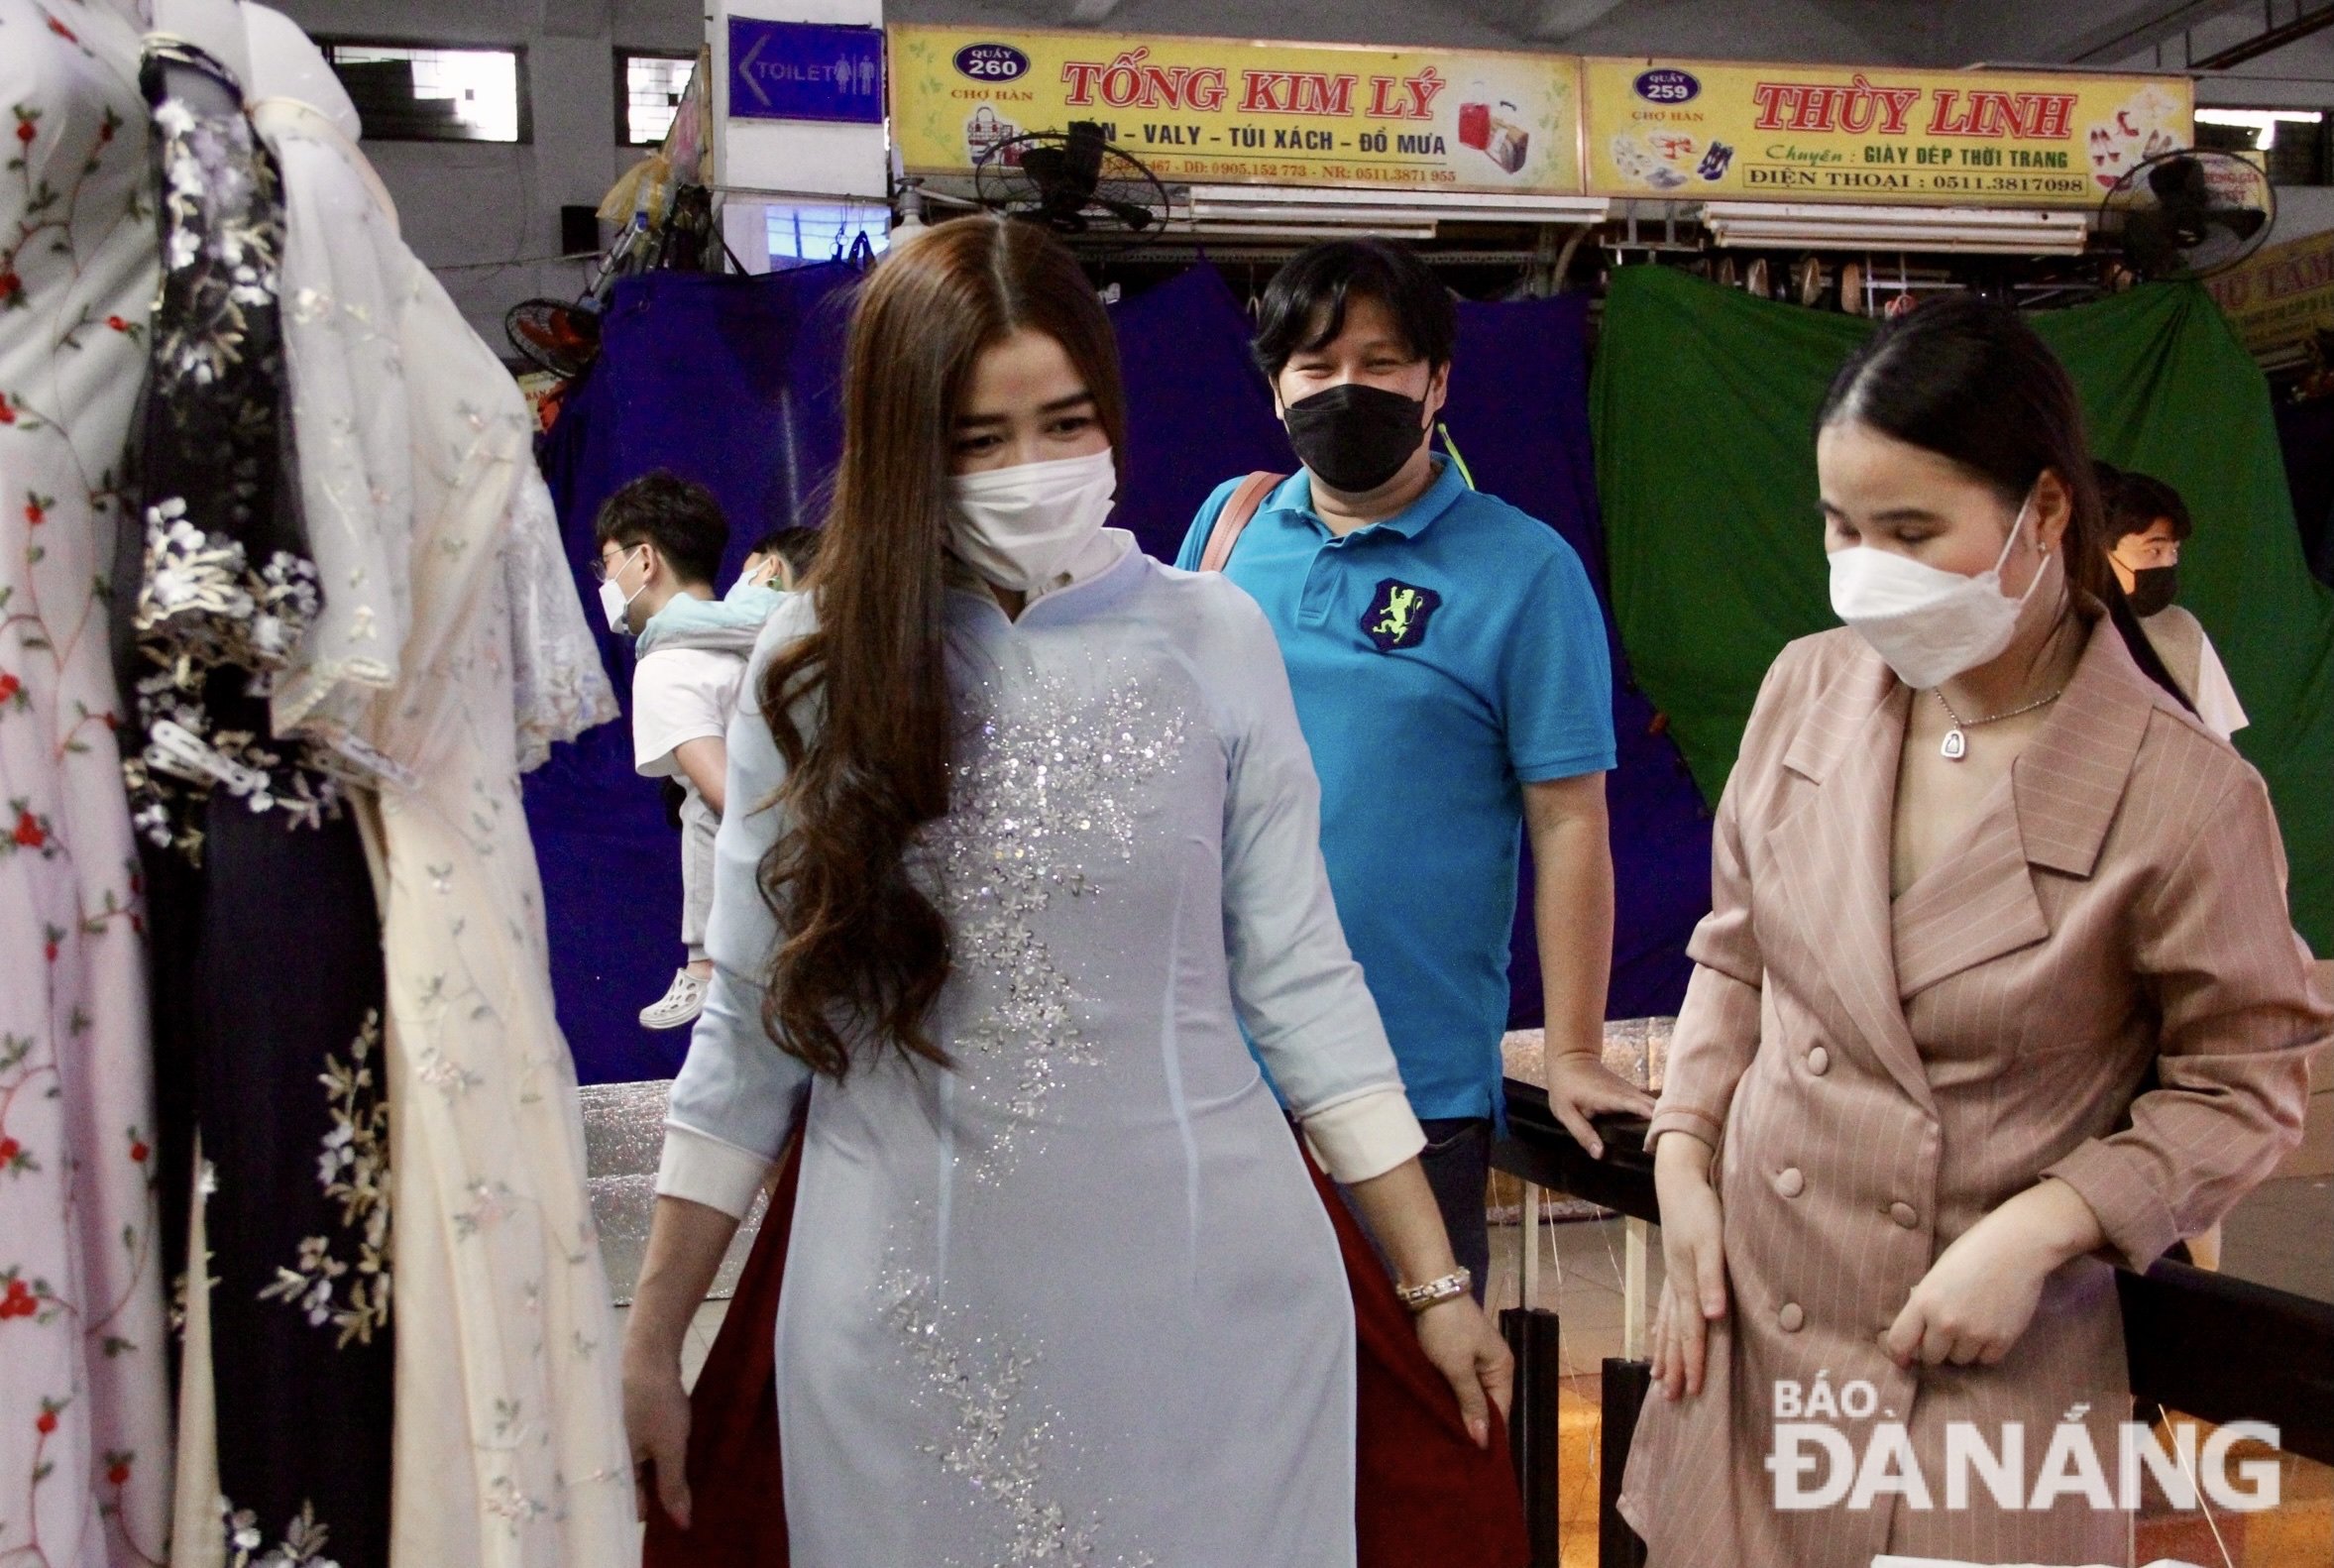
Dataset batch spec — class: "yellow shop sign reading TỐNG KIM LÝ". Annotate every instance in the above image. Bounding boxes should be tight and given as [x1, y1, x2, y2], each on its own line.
[889, 24, 1580, 196]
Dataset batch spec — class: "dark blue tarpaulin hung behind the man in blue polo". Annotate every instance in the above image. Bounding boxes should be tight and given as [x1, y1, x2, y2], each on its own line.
[527, 266, 1709, 1082]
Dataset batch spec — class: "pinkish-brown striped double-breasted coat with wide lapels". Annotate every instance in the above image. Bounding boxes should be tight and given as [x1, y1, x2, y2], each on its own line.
[1622, 623, 2334, 1568]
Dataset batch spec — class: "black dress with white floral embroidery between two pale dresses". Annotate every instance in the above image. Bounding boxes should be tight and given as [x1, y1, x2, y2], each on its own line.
[121, 0, 394, 1568]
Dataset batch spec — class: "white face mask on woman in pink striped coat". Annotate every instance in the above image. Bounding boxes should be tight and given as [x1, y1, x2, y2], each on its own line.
[1833, 497, 2050, 688]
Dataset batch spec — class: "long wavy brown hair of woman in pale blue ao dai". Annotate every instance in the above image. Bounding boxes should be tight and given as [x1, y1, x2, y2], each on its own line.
[756, 217, 1125, 1078]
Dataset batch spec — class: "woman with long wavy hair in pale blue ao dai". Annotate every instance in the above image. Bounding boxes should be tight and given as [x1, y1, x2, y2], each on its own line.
[623, 217, 1510, 1568]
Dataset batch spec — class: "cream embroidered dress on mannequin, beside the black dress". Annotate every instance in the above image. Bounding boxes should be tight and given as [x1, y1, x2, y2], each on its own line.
[241, 5, 639, 1568]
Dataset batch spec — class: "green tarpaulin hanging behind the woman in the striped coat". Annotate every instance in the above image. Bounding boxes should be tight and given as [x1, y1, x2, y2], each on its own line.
[1590, 266, 2334, 954]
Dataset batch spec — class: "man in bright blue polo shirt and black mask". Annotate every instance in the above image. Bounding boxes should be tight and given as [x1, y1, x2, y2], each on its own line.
[1176, 240, 1652, 1297]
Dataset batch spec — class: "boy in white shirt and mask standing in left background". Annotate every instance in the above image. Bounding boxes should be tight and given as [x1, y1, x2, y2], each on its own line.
[593, 469, 741, 1029]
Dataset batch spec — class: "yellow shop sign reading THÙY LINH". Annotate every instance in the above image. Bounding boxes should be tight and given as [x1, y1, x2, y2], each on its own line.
[1580, 58, 2196, 208]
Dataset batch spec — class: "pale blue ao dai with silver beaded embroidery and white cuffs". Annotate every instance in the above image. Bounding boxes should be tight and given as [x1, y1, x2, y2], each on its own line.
[660, 548, 1416, 1568]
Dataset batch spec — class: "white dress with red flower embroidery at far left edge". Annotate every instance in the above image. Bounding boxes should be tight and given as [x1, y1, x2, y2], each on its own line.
[0, 0, 170, 1568]
